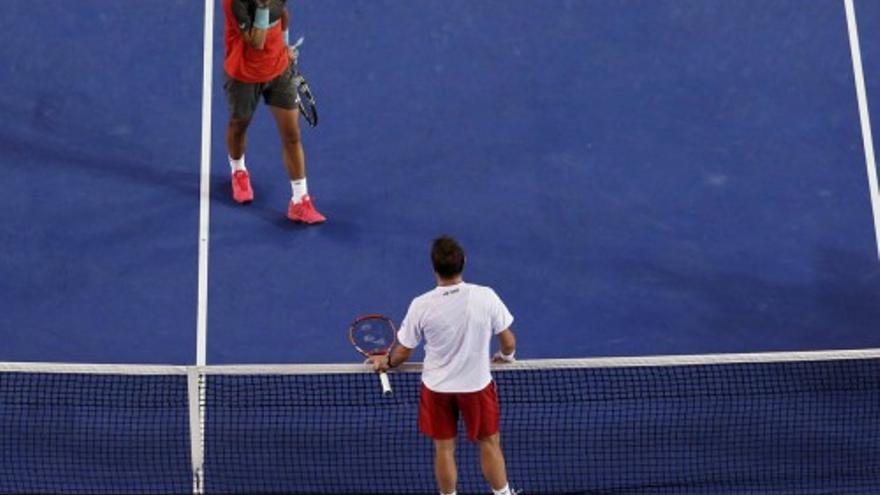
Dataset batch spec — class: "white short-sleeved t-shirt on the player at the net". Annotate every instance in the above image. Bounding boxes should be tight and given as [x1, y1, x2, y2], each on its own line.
[397, 282, 513, 392]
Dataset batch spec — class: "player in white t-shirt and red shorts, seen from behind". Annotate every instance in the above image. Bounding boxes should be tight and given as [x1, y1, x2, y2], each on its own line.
[373, 237, 516, 495]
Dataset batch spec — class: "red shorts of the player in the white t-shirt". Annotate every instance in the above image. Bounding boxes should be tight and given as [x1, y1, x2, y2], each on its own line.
[419, 382, 500, 442]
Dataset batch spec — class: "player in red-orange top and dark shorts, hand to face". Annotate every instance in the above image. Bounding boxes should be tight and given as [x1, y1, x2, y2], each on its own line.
[223, 0, 326, 224]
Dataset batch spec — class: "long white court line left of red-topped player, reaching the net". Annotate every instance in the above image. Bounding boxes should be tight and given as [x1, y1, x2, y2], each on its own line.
[196, 0, 214, 366]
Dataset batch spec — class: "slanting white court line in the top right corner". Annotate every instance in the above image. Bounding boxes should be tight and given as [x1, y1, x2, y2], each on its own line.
[843, 0, 880, 258]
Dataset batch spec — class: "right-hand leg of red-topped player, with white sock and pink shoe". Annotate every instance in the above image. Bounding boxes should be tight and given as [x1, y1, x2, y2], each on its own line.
[269, 106, 326, 224]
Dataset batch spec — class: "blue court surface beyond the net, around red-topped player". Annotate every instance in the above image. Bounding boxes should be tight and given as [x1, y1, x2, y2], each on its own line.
[0, 0, 880, 364]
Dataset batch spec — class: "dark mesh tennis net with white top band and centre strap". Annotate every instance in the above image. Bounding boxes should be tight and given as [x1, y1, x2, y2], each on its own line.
[0, 350, 880, 495]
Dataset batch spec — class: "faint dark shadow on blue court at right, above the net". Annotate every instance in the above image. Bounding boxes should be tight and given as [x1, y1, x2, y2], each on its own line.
[620, 248, 880, 350]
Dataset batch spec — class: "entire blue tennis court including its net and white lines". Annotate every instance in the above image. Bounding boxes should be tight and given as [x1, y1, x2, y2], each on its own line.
[0, 0, 880, 495]
